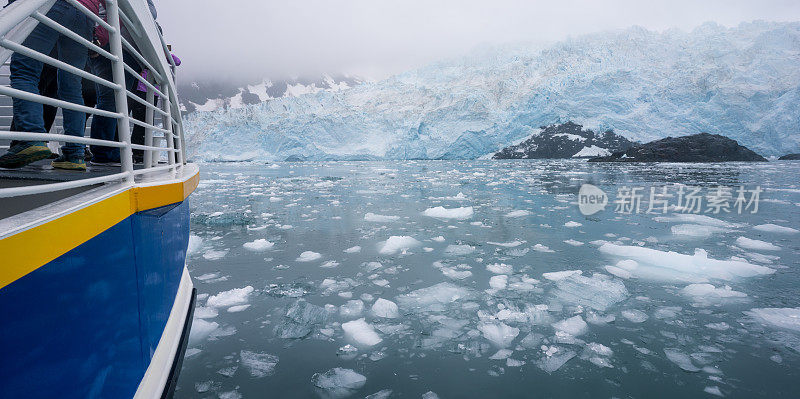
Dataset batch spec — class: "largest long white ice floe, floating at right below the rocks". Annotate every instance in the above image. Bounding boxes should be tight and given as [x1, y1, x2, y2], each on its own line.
[599, 243, 775, 282]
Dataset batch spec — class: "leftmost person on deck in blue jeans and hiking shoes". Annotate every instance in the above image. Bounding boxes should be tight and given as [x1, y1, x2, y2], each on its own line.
[0, 0, 105, 170]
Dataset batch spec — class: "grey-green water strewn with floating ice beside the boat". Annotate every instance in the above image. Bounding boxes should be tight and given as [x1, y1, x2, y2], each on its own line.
[176, 161, 800, 398]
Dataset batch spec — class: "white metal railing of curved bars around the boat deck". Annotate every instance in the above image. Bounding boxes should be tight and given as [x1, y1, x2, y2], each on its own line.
[0, 0, 185, 198]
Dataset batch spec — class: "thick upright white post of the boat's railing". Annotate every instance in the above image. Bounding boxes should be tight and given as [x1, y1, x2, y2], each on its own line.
[106, 0, 134, 184]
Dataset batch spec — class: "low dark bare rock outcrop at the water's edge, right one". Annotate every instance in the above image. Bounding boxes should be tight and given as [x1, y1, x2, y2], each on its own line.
[589, 133, 766, 162]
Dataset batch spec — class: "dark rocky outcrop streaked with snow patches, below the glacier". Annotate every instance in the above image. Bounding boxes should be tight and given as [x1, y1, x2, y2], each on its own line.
[492, 122, 636, 159]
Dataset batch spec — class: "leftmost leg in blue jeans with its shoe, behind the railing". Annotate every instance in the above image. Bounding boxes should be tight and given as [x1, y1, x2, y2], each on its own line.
[0, 2, 62, 168]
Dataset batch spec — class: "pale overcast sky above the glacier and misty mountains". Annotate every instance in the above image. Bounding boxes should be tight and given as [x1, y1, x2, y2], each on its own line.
[154, 0, 800, 81]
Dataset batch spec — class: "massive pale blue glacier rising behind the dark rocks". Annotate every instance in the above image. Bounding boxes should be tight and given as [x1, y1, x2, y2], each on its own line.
[184, 21, 800, 161]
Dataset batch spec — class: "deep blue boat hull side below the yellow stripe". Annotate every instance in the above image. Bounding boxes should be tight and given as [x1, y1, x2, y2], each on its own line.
[0, 201, 189, 398]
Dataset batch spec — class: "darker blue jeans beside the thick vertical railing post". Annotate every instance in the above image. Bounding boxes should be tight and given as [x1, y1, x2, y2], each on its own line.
[89, 46, 141, 162]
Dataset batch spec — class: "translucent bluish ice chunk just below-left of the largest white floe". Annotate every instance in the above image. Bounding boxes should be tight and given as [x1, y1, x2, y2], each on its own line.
[553, 273, 628, 312]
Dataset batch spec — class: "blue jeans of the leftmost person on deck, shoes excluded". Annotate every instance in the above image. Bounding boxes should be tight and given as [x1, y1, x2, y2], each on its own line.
[10, 0, 94, 157]
